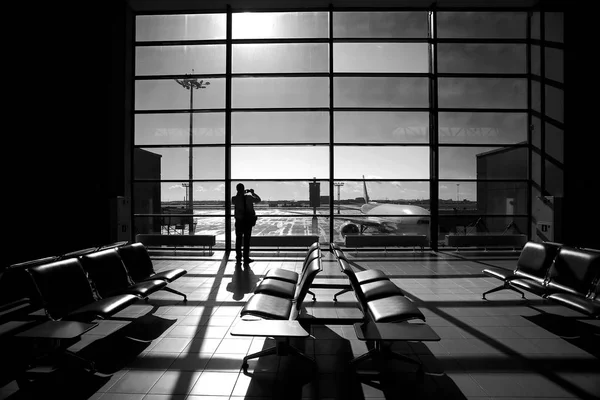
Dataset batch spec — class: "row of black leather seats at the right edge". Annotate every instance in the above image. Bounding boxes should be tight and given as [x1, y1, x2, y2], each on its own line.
[483, 242, 600, 319]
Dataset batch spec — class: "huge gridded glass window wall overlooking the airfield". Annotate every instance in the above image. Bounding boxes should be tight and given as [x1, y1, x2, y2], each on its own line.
[131, 7, 552, 250]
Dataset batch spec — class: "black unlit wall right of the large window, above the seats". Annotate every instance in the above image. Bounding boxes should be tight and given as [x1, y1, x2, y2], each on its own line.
[562, 9, 600, 249]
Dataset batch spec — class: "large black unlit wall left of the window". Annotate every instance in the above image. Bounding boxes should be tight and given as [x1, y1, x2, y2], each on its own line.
[2, 0, 126, 266]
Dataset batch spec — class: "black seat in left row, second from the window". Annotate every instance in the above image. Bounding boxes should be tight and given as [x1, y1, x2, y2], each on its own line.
[80, 248, 167, 299]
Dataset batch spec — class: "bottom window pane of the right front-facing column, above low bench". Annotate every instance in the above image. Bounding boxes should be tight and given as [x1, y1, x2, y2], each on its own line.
[439, 215, 527, 239]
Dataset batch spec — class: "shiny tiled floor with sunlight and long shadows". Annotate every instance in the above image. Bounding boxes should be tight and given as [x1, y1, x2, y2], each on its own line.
[0, 248, 600, 400]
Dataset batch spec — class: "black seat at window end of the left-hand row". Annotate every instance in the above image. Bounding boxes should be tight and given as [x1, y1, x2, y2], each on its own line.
[117, 243, 187, 302]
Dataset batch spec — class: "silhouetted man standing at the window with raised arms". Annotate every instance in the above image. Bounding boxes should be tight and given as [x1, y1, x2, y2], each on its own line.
[231, 183, 261, 264]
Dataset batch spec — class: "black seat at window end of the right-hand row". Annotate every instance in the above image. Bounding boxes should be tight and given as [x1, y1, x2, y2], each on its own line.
[482, 242, 560, 300]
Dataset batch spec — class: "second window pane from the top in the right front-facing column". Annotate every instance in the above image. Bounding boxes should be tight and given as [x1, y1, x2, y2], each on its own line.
[437, 43, 527, 73]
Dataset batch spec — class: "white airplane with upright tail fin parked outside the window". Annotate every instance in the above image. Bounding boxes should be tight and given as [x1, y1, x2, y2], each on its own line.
[340, 175, 430, 237]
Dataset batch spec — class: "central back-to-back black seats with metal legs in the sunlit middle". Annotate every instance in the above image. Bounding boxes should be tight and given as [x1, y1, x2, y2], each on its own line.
[240, 242, 439, 377]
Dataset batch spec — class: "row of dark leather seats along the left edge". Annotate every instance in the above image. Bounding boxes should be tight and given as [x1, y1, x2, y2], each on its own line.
[0, 243, 187, 385]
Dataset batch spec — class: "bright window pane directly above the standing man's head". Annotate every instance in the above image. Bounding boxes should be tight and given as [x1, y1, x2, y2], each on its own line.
[231, 146, 329, 180]
